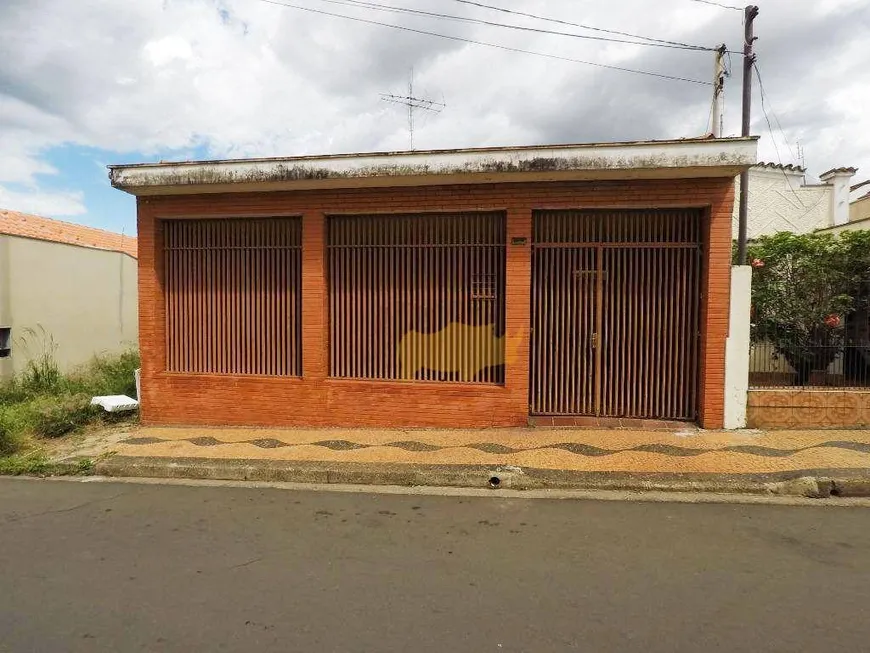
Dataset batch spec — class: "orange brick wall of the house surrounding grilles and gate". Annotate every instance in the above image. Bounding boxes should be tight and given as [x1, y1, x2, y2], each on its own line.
[138, 179, 734, 428]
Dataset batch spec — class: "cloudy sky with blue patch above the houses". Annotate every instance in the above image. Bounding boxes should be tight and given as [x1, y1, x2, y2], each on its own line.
[0, 0, 870, 234]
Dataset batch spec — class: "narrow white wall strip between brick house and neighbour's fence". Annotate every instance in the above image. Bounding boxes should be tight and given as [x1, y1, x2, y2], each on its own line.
[725, 265, 752, 429]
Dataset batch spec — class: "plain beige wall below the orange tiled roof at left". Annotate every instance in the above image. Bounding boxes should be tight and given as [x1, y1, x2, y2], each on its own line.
[0, 235, 139, 376]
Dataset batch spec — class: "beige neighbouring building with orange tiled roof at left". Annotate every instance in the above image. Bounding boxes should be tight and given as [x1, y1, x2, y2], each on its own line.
[0, 210, 139, 378]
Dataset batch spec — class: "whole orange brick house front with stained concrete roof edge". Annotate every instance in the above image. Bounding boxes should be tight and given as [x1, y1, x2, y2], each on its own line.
[110, 138, 756, 428]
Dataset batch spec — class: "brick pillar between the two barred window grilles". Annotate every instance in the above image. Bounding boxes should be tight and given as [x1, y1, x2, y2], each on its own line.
[302, 211, 329, 380]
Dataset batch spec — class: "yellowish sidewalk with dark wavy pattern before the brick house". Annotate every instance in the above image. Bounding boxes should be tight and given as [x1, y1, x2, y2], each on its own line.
[71, 427, 870, 496]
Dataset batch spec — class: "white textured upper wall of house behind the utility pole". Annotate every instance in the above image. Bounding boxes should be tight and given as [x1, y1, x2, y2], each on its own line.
[733, 168, 833, 238]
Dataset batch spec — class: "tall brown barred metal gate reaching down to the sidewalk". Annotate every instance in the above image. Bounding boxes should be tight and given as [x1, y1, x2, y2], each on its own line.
[529, 209, 701, 420]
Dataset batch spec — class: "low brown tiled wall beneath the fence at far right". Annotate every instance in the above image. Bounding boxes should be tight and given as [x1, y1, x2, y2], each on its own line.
[746, 389, 870, 429]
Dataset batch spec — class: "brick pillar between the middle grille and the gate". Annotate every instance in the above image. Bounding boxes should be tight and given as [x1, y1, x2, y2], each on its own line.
[505, 209, 532, 424]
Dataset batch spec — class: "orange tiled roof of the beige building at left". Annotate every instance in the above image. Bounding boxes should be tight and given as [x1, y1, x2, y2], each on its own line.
[0, 209, 139, 258]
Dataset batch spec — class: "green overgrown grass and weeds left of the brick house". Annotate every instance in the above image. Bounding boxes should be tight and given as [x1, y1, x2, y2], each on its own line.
[0, 331, 139, 466]
